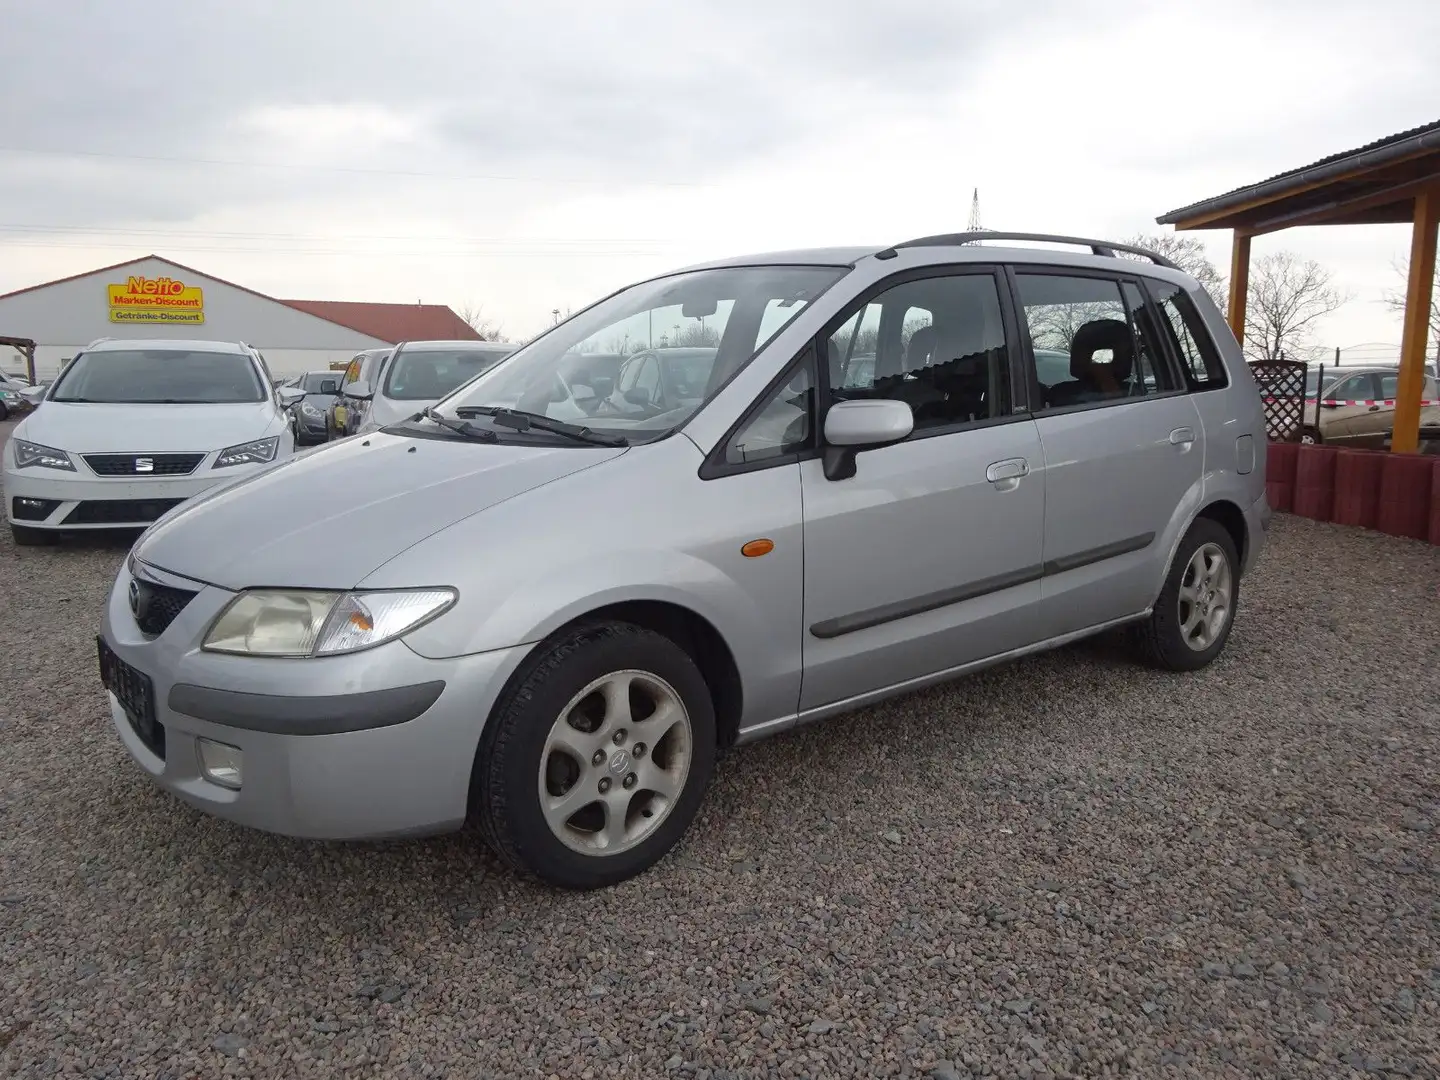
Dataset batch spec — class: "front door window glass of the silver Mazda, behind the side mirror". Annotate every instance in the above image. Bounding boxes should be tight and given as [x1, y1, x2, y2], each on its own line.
[827, 274, 1007, 431]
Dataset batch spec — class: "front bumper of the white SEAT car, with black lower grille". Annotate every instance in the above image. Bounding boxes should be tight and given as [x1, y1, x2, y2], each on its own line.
[4, 462, 265, 531]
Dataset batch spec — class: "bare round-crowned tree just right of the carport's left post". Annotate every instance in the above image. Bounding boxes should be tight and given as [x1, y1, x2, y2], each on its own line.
[1244, 251, 1351, 360]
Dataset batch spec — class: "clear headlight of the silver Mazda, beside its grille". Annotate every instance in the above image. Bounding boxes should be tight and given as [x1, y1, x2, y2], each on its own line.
[202, 589, 455, 657]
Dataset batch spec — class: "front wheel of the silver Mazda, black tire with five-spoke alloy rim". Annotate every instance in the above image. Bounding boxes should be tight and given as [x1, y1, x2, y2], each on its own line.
[472, 622, 716, 888]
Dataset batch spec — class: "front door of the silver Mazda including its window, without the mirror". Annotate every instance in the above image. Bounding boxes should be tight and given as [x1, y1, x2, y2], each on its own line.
[801, 268, 1045, 713]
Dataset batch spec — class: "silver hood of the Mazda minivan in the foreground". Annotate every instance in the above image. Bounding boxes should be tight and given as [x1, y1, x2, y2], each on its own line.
[135, 433, 625, 589]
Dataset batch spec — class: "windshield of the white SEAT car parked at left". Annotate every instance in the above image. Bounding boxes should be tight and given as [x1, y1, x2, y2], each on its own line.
[50, 348, 268, 405]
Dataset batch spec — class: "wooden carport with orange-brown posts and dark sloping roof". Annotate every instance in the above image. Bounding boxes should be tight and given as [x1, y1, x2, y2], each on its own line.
[1155, 121, 1440, 451]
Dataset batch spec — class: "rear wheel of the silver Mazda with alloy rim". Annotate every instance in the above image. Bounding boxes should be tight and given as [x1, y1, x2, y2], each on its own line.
[1136, 517, 1240, 671]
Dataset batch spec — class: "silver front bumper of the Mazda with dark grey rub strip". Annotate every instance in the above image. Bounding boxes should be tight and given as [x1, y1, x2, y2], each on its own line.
[101, 567, 526, 840]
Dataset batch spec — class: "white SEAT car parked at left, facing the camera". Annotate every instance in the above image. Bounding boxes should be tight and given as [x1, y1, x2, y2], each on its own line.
[3, 340, 304, 544]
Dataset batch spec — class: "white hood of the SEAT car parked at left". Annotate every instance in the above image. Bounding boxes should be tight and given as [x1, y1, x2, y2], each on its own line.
[20, 402, 282, 454]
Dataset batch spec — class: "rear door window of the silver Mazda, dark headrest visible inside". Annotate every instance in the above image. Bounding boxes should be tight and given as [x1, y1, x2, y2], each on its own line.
[1017, 274, 1172, 410]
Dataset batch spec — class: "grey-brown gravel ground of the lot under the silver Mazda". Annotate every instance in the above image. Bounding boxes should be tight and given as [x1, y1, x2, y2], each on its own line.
[0, 417, 1440, 1080]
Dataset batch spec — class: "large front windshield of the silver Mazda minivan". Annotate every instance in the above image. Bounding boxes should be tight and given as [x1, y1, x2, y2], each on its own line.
[441, 266, 847, 441]
